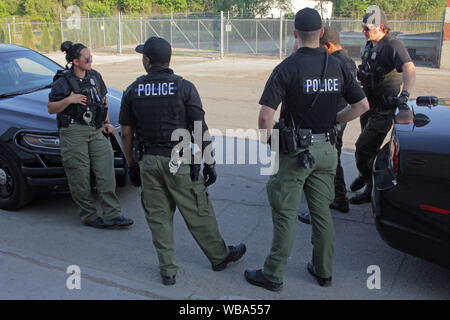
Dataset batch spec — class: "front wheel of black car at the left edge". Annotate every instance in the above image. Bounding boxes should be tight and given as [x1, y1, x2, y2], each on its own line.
[0, 152, 33, 210]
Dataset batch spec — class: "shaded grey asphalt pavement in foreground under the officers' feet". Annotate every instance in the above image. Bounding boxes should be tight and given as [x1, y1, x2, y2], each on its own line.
[0, 136, 450, 300]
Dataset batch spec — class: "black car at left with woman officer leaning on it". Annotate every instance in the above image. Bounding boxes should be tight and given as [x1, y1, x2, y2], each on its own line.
[0, 44, 126, 210]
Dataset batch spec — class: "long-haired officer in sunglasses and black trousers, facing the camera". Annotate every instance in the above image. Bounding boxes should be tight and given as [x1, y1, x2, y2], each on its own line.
[350, 10, 416, 204]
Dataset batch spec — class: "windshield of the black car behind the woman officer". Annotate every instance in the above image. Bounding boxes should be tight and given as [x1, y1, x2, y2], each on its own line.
[0, 51, 61, 95]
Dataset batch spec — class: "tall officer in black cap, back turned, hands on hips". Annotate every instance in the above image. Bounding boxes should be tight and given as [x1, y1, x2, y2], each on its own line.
[245, 8, 369, 291]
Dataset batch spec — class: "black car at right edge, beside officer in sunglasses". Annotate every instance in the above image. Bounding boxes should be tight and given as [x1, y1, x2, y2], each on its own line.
[372, 97, 450, 268]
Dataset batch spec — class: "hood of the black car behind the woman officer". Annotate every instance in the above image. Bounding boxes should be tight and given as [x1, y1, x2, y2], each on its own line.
[0, 88, 122, 131]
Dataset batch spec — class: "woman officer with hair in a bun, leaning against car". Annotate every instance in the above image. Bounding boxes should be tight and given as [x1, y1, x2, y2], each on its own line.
[47, 41, 133, 228]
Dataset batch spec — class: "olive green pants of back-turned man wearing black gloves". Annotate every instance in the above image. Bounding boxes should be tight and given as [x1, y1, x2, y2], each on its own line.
[139, 155, 229, 276]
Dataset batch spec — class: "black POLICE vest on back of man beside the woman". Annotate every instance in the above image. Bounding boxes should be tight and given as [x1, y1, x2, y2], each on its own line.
[132, 73, 186, 147]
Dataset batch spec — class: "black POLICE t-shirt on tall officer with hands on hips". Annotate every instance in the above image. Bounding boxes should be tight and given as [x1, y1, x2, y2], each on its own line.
[259, 47, 365, 132]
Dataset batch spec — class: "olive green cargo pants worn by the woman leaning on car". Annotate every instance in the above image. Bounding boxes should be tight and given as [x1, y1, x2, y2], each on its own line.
[59, 124, 121, 222]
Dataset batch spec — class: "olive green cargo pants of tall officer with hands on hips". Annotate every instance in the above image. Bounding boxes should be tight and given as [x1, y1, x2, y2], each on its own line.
[263, 142, 337, 283]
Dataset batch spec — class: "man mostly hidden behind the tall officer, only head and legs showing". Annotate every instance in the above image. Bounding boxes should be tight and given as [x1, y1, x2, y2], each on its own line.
[298, 27, 356, 224]
